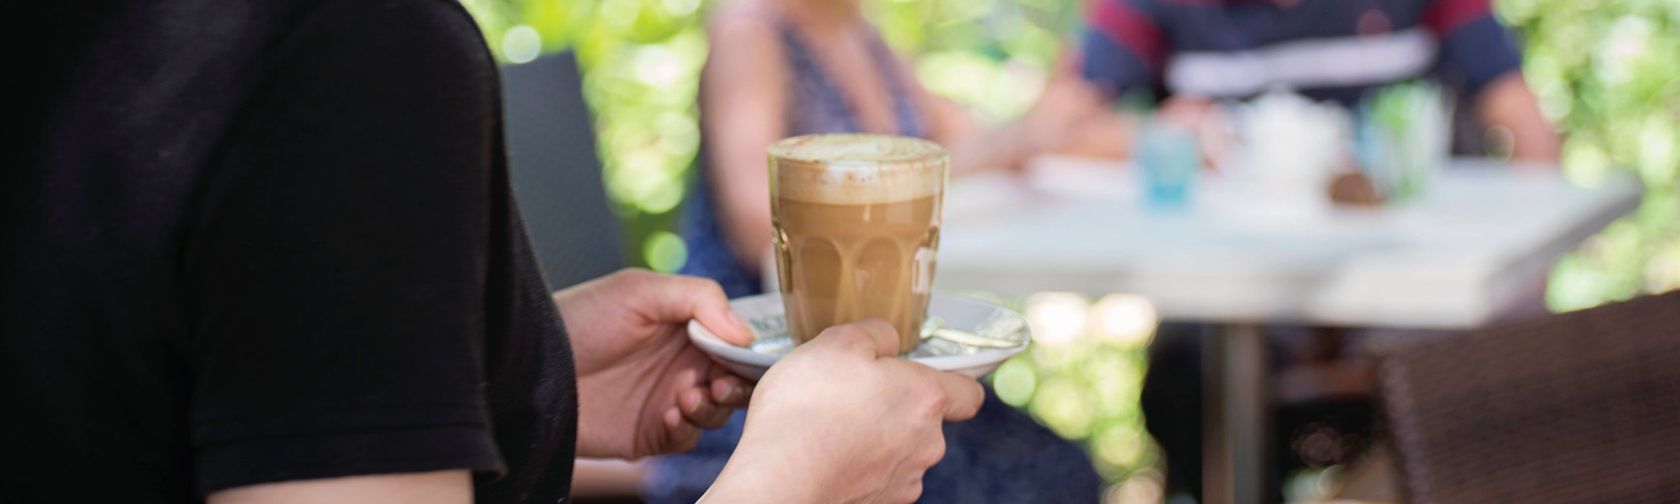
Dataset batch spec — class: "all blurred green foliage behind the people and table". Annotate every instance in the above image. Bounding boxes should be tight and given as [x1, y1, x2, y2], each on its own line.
[464, 0, 1680, 490]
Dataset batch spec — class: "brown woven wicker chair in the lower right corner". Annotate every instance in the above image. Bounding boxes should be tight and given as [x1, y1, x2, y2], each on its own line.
[1379, 292, 1680, 504]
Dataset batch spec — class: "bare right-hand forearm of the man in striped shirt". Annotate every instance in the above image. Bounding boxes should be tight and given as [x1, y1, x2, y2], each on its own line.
[1475, 71, 1561, 163]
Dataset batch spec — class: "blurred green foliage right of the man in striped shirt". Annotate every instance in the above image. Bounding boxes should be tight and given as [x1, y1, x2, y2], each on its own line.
[1497, 0, 1680, 311]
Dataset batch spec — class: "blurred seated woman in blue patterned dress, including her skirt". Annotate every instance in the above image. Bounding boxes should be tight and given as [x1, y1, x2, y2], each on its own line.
[608, 0, 1102, 502]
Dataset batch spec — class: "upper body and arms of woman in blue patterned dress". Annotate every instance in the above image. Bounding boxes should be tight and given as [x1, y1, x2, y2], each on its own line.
[684, 0, 1102, 297]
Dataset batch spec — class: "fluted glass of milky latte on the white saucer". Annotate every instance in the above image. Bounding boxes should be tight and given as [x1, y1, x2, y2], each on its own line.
[769, 134, 949, 354]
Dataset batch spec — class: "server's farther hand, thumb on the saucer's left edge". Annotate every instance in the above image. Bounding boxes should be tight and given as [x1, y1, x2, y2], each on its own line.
[554, 269, 753, 459]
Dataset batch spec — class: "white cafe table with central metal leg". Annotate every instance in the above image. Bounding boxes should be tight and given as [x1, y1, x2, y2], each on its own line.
[936, 158, 1641, 502]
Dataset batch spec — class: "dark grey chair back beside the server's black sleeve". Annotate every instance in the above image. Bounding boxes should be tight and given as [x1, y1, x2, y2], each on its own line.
[502, 52, 625, 289]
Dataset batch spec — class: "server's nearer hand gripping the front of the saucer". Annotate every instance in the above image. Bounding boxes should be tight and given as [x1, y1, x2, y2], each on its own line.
[701, 319, 983, 502]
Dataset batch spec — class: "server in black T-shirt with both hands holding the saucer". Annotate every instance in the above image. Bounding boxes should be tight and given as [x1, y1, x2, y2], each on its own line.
[0, 0, 983, 502]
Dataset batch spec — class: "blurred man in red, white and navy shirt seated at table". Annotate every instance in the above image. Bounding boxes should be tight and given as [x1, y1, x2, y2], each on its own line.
[1082, 0, 1559, 496]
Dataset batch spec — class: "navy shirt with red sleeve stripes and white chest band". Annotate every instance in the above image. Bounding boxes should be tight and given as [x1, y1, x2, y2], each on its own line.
[1084, 0, 1522, 104]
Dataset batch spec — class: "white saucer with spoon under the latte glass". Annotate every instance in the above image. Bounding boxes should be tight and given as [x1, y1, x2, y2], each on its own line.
[689, 292, 1032, 380]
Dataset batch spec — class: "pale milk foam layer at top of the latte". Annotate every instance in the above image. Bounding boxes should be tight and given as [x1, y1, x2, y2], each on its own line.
[769, 134, 949, 205]
